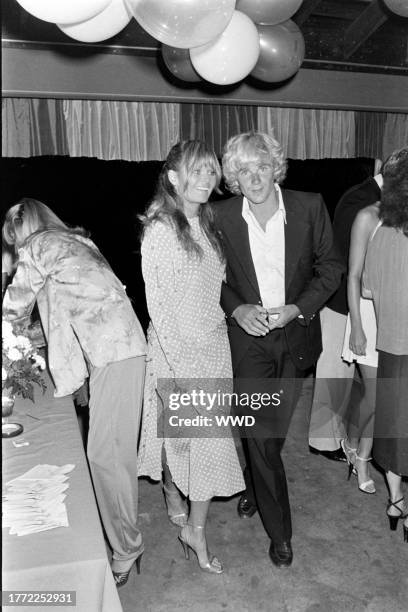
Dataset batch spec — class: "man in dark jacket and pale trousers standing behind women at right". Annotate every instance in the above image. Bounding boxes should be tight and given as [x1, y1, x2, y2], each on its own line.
[309, 170, 383, 456]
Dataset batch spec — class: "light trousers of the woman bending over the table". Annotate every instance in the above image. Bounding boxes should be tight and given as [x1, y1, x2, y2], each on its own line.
[87, 355, 145, 561]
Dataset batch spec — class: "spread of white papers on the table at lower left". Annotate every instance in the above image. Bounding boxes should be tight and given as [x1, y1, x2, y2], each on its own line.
[2, 464, 75, 536]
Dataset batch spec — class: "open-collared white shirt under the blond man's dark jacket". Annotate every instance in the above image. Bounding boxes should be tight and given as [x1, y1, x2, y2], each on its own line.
[242, 185, 286, 308]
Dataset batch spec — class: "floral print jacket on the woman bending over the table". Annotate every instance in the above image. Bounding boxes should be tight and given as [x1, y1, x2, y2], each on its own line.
[3, 229, 146, 397]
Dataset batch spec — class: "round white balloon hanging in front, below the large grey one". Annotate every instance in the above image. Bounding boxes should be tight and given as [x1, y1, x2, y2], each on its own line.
[190, 11, 259, 85]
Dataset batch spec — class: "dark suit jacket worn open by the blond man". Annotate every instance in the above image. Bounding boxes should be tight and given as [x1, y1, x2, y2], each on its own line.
[214, 190, 343, 370]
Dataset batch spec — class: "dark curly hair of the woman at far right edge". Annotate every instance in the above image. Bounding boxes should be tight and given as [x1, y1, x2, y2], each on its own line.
[379, 147, 408, 237]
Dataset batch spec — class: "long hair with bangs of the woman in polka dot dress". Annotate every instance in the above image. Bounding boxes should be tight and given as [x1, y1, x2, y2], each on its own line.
[139, 140, 223, 260]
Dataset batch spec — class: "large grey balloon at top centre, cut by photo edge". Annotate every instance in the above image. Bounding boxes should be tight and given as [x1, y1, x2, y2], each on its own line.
[126, 0, 235, 49]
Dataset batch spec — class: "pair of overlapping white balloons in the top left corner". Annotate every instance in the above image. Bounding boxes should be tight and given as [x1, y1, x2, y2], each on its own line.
[17, 0, 132, 43]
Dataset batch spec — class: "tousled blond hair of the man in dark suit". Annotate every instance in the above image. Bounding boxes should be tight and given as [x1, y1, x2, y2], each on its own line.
[222, 132, 287, 194]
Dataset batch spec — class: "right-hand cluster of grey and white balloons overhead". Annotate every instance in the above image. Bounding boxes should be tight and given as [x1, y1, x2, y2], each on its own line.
[158, 0, 305, 85]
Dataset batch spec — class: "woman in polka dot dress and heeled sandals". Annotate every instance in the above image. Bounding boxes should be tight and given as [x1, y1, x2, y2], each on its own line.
[138, 140, 245, 574]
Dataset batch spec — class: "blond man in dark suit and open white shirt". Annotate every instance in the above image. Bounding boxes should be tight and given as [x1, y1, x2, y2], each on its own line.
[215, 132, 343, 567]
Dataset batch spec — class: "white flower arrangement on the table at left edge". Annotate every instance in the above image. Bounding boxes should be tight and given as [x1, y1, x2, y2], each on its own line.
[1, 319, 46, 401]
